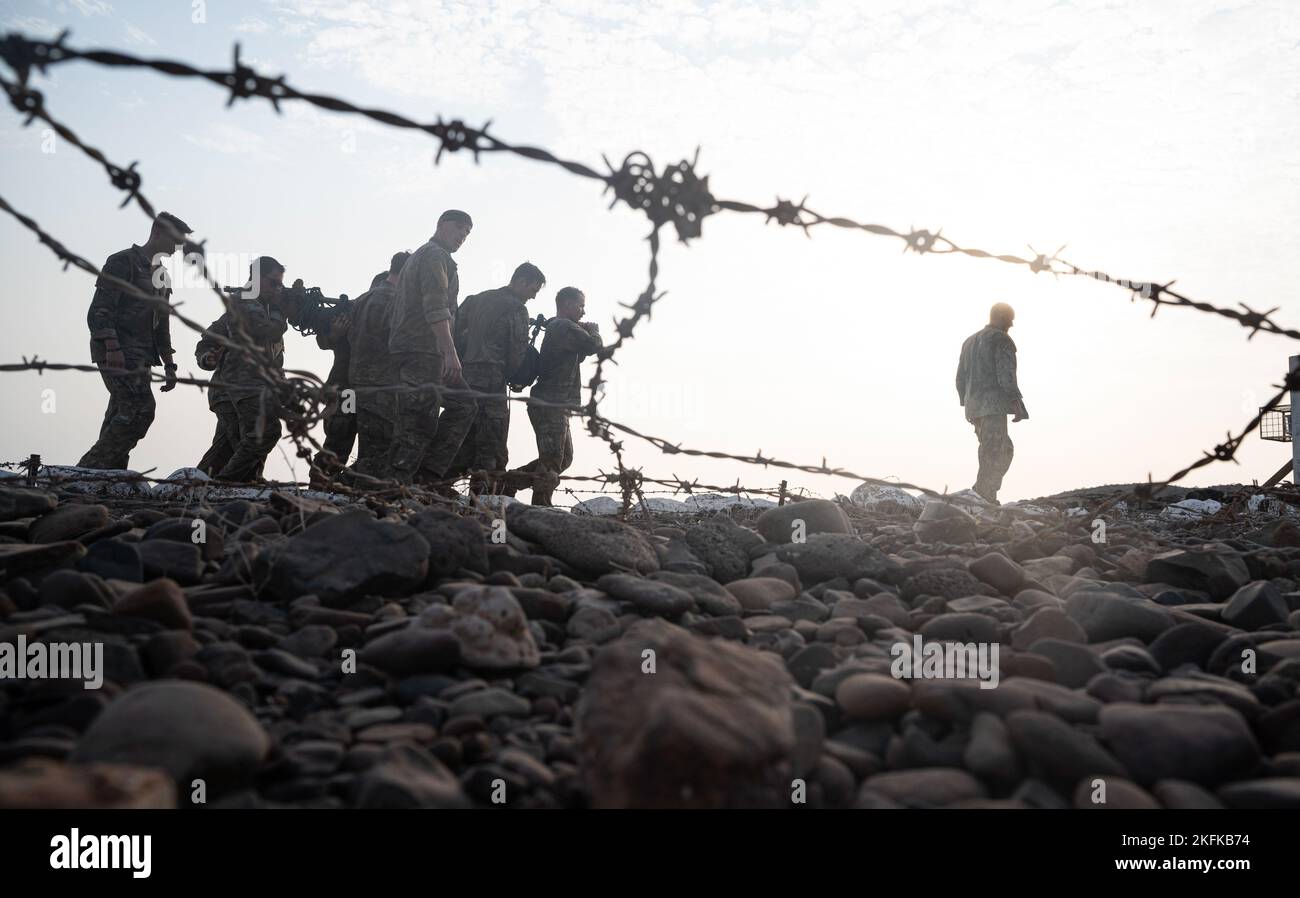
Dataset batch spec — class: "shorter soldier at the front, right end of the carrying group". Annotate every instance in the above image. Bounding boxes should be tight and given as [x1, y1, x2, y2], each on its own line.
[519, 287, 602, 506]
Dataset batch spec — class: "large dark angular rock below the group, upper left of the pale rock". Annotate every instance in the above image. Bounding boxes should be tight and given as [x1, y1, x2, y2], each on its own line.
[270, 513, 429, 606]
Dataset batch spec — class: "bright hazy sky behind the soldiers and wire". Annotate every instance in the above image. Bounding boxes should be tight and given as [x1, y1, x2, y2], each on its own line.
[0, 0, 1300, 499]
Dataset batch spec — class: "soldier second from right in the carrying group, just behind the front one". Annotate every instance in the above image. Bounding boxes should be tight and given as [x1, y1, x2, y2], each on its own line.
[423, 263, 546, 486]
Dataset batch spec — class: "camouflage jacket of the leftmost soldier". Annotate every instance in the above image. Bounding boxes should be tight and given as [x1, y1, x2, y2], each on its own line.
[86, 244, 172, 365]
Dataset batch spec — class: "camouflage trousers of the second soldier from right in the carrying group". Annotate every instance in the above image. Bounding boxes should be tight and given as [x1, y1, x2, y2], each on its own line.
[421, 370, 510, 480]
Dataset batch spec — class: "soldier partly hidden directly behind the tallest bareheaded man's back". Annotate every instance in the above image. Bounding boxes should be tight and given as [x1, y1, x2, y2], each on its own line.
[347, 252, 411, 477]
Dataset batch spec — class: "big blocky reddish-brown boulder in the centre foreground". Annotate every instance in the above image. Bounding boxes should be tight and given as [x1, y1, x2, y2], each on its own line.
[577, 620, 794, 807]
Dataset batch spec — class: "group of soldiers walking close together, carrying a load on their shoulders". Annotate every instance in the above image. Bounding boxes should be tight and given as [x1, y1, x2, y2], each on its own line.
[79, 209, 603, 506]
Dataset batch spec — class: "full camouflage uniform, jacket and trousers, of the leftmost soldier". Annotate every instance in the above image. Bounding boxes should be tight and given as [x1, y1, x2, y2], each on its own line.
[77, 244, 172, 468]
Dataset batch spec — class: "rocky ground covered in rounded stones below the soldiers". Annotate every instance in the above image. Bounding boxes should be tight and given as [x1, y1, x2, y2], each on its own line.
[0, 478, 1300, 808]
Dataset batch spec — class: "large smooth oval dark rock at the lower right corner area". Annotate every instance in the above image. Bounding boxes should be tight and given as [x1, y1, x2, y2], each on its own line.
[1100, 703, 1260, 785]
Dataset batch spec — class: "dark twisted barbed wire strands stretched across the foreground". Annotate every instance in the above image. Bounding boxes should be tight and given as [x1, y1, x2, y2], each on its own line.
[0, 31, 1300, 527]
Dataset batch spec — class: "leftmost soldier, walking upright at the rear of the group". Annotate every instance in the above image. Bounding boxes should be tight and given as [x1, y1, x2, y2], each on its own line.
[77, 212, 190, 468]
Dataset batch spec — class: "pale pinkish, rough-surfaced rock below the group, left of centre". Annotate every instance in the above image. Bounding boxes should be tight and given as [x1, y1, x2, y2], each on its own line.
[419, 586, 538, 671]
